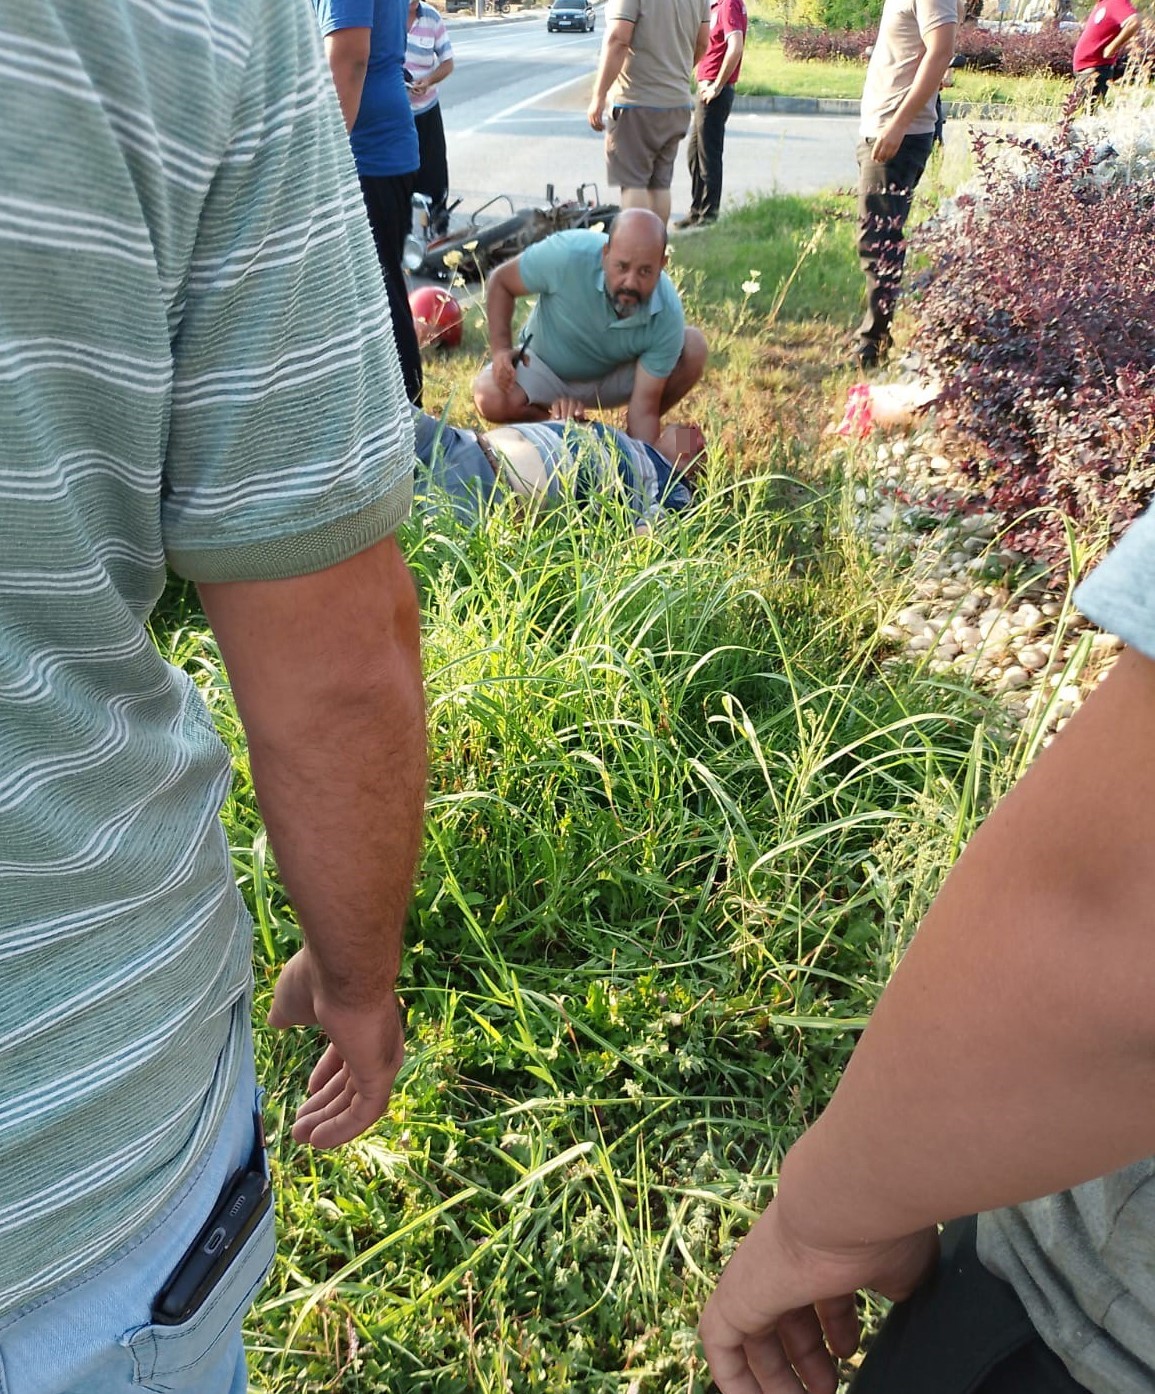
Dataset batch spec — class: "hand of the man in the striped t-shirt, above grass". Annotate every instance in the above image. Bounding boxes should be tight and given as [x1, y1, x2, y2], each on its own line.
[269, 948, 405, 1147]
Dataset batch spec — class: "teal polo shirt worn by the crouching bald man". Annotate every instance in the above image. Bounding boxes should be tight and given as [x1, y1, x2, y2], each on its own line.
[518, 229, 685, 382]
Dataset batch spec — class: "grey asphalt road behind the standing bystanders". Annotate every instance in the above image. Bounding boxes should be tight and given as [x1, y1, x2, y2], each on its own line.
[431, 8, 857, 217]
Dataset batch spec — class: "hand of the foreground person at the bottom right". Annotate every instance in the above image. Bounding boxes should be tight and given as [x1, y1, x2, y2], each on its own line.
[698, 1202, 939, 1394]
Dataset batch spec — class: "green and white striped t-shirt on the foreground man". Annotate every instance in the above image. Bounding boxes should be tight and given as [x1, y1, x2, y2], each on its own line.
[0, 0, 412, 1312]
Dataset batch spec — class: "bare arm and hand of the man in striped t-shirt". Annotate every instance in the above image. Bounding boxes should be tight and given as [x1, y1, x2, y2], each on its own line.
[201, 538, 425, 1147]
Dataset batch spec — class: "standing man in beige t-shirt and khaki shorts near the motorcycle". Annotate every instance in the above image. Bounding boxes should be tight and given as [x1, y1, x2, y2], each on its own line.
[587, 0, 709, 222]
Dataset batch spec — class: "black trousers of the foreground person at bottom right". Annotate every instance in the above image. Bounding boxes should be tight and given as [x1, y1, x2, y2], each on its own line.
[850, 1216, 1087, 1394]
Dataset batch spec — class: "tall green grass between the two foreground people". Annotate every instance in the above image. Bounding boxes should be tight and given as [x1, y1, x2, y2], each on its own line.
[140, 199, 1047, 1394]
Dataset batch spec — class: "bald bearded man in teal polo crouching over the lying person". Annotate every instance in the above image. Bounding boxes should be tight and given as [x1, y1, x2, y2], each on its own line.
[474, 208, 706, 445]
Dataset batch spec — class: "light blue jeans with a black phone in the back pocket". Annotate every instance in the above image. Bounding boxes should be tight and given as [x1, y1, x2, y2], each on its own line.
[0, 1027, 274, 1394]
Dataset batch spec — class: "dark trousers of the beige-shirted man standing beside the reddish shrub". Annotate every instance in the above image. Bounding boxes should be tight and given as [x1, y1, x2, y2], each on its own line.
[858, 131, 935, 347]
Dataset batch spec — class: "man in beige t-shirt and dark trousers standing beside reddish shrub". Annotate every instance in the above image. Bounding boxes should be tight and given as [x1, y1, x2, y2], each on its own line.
[854, 0, 963, 368]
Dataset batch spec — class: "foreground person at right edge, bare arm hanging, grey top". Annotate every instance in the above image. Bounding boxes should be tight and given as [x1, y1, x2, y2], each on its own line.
[701, 496, 1155, 1394]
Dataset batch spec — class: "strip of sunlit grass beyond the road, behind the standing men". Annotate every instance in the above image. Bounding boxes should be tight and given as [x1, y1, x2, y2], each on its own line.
[738, 15, 1070, 118]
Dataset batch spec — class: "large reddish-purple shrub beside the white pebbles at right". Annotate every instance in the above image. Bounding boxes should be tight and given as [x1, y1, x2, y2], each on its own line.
[915, 127, 1155, 563]
